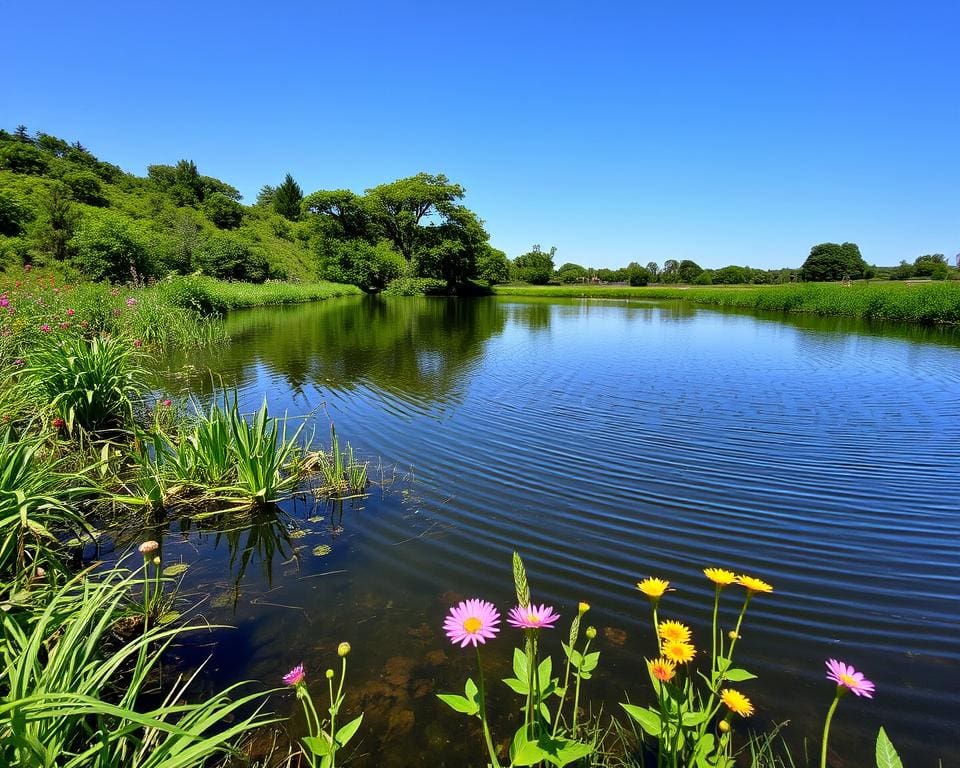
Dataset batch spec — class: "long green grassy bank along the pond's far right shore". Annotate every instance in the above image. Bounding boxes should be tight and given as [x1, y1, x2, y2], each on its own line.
[494, 282, 960, 324]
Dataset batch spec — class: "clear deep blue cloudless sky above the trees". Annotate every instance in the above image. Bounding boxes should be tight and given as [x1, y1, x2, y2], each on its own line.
[0, 0, 960, 267]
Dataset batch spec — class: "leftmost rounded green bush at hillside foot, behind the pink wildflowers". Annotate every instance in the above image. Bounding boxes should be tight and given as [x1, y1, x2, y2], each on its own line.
[71, 210, 151, 283]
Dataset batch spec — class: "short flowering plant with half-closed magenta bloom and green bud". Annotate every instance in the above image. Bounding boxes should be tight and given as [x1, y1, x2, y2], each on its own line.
[283, 643, 363, 768]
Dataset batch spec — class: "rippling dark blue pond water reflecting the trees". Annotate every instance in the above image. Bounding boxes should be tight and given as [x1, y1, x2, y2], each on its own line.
[141, 298, 960, 766]
